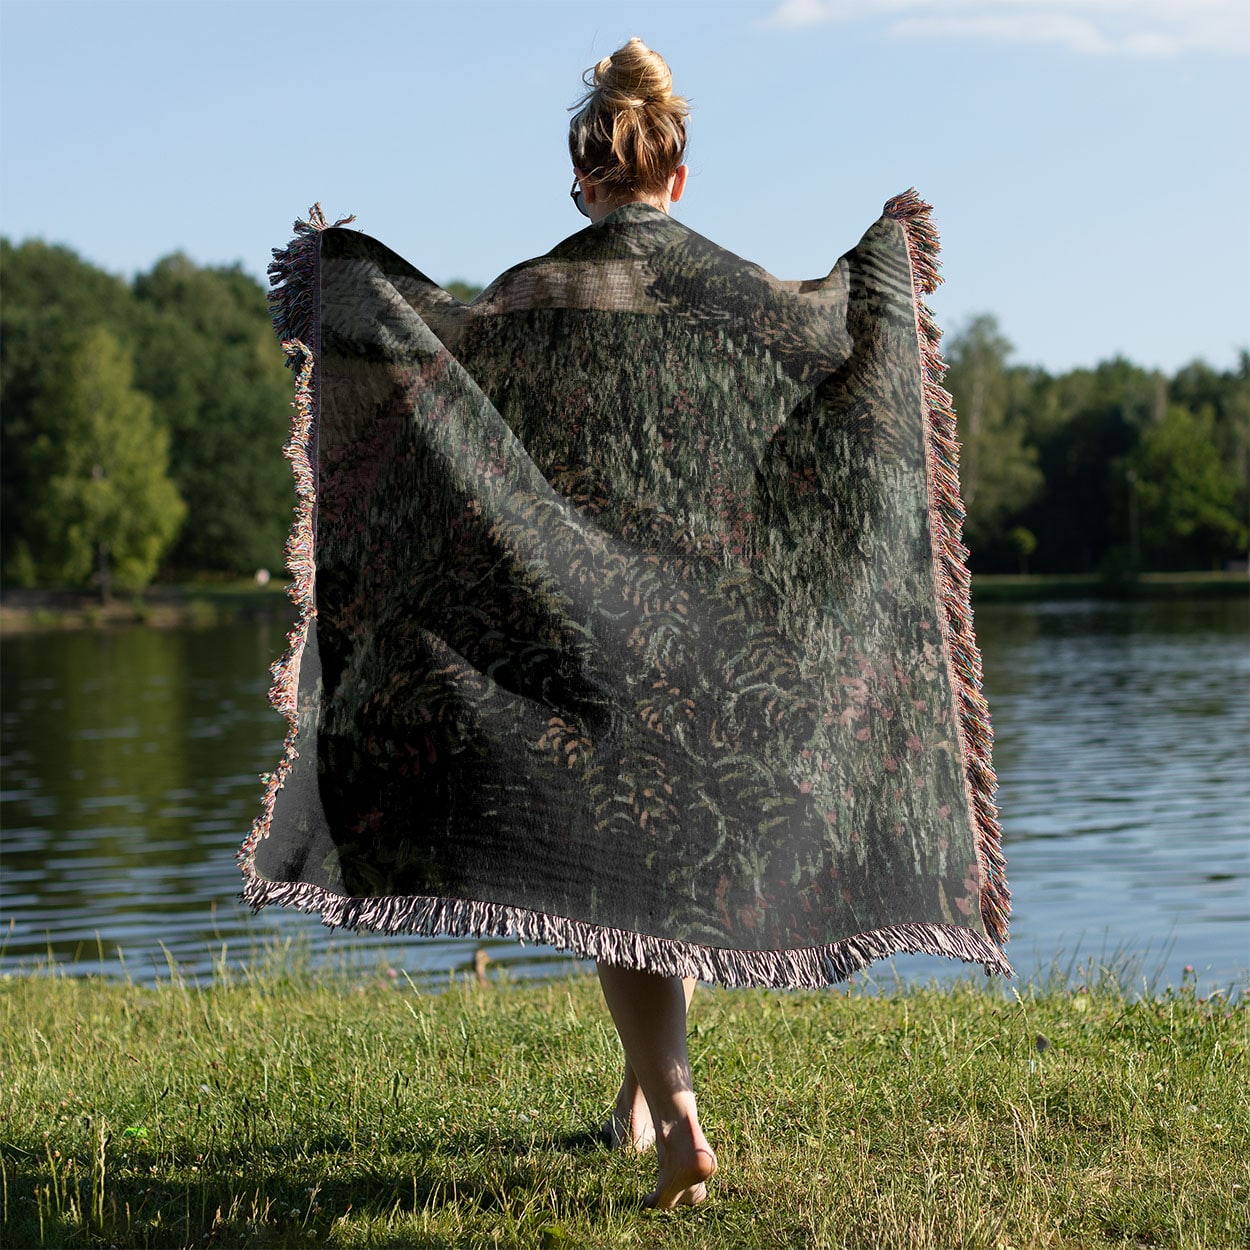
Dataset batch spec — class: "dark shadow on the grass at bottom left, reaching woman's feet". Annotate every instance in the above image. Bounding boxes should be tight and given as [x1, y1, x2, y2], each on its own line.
[7, 1129, 641, 1248]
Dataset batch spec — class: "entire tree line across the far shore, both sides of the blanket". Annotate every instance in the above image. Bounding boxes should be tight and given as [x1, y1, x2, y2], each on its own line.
[0, 239, 1250, 595]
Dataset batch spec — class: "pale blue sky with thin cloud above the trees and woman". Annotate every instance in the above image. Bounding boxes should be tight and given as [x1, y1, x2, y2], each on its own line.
[0, 0, 1250, 371]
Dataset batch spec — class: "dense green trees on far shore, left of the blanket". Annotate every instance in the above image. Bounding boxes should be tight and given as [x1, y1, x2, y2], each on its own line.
[0, 240, 291, 593]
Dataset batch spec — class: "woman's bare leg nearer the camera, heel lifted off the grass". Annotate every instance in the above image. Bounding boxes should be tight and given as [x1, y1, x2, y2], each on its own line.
[599, 964, 716, 1209]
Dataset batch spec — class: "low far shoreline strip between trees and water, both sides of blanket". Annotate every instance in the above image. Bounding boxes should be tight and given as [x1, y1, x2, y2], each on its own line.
[0, 573, 1250, 638]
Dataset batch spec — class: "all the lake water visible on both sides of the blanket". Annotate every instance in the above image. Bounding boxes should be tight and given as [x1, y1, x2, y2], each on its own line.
[0, 600, 1250, 988]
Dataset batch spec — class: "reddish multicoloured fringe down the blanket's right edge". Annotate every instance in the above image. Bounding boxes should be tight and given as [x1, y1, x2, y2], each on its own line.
[884, 188, 1011, 943]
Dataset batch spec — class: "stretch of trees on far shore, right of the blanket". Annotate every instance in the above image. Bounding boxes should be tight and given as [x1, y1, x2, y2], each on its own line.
[945, 316, 1250, 578]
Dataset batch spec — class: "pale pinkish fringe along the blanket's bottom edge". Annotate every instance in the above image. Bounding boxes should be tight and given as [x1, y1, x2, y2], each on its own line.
[244, 876, 1013, 989]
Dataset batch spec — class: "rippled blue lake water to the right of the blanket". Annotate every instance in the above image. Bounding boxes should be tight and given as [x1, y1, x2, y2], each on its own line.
[978, 600, 1250, 985]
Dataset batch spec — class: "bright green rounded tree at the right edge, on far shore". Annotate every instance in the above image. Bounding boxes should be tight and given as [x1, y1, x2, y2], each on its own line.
[1133, 404, 1248, 568]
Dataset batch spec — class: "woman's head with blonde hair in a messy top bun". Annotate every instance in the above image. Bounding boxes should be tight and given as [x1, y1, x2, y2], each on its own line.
[569, 39, 690, 200]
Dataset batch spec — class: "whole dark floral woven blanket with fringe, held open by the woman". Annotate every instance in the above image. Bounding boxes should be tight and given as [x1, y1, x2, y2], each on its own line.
[240, 193, 1011, 986]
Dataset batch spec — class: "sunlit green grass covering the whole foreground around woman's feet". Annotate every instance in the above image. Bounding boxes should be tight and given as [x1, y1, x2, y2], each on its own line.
[0, 966, 1250, 1250]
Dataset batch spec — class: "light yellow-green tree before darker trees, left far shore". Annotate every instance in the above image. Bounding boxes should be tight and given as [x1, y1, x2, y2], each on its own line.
[26, 326, 185, 600]
